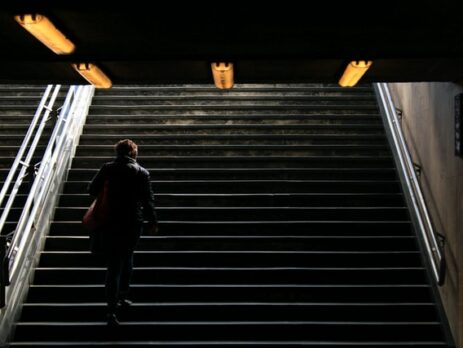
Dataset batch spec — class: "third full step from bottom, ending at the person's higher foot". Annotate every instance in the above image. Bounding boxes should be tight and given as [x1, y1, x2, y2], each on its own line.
[28, 281, 432, 305]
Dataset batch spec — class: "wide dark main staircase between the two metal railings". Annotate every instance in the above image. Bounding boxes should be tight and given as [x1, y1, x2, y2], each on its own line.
[7, 85, 450, 347]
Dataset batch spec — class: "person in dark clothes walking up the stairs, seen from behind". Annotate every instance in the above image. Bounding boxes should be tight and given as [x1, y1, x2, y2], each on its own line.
[88, 139, 158, 325]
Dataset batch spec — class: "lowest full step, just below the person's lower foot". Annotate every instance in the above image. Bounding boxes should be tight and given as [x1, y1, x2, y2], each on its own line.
[12, 321, 441, 344]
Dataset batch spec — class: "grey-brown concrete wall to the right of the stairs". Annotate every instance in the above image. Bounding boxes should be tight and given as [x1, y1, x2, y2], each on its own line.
[389, 83, 463, 348]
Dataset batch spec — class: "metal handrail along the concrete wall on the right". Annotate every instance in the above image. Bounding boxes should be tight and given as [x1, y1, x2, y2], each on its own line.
[374, 83, 446, 285]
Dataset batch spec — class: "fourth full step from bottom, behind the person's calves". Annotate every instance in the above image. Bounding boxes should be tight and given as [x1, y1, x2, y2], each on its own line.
[30, 267, 426, 285]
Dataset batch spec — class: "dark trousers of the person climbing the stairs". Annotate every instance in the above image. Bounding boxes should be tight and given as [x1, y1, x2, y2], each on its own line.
[106, 251, 133, 313]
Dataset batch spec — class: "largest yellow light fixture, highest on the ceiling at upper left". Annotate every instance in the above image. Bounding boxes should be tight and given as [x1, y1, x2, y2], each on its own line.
[14, 14, 76, 54]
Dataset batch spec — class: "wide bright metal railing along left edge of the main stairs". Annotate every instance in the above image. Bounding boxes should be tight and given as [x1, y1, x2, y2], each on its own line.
[0, 86, 94, 346]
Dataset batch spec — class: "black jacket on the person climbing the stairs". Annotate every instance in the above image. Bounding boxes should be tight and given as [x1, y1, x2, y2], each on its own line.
[88, 157, 157, 234]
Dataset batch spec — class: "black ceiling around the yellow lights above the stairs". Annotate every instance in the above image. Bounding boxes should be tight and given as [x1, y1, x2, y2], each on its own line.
[0, 0, 463, 84]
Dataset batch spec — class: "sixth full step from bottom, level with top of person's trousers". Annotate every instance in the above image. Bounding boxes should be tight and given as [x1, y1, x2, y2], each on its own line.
[46, 235, 418, 251]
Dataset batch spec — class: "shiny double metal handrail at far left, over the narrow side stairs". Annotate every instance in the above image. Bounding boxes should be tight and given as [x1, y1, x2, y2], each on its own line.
[0, 85, 61, 232]
